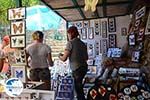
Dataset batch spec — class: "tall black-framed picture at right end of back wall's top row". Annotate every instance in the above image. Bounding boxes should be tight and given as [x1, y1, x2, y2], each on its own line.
[108, 17, 116, 32]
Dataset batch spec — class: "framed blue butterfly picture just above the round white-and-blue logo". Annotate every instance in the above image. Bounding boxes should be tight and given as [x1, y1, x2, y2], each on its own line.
[11, 66, 27, 82]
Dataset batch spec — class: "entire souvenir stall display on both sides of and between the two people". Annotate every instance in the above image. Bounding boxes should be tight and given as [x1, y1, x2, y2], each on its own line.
[1, 0, 150, 100]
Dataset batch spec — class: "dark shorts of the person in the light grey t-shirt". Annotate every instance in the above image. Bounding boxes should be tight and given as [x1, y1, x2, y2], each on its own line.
[30, 68, 50, 81]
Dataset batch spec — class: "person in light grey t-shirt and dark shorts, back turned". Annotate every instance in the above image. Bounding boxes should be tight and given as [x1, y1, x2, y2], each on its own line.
[26, 31, 53, 90]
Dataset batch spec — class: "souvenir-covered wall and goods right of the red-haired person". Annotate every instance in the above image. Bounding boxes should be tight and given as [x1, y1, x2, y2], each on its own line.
[69, 6, 150, 100]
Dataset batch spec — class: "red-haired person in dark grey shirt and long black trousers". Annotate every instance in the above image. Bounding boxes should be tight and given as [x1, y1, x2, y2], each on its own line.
[59, 26, 88, 100]
